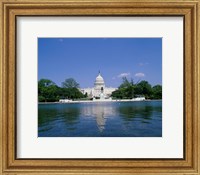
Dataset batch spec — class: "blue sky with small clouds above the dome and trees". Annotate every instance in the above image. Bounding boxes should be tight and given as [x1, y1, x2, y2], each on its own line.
[38, 38, 162, 88]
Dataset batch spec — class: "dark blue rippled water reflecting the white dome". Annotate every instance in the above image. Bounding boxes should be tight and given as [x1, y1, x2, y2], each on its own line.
[38, 101, 162, 137]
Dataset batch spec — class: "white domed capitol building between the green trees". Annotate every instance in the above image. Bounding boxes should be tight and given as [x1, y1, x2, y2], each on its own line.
[81, 72, 117, 99]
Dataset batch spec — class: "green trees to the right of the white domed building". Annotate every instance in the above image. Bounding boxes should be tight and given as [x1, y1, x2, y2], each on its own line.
[111, 77, 162, 99]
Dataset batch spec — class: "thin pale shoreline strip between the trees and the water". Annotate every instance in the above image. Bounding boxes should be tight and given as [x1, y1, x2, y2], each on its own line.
[38, 99, 162, 104]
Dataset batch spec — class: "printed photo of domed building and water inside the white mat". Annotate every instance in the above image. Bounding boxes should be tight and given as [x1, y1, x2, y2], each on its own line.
[38, 37, 162, 139]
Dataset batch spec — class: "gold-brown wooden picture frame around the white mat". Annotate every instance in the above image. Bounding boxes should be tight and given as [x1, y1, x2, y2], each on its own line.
[0, 0, 200, 174]
